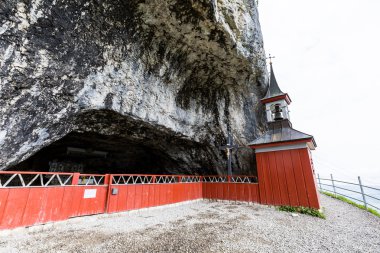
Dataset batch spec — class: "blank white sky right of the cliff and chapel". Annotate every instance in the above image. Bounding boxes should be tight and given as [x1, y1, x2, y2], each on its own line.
[259, 0, 380, 185]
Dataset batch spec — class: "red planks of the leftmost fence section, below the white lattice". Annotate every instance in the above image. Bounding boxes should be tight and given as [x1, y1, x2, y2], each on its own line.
[0, 186, 107, 229]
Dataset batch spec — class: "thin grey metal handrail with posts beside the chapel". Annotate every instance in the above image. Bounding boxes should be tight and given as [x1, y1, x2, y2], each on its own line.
[317, 174, 380, 210]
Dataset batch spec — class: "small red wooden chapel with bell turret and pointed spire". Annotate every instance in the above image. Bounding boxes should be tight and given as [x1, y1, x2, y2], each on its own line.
[249, 63, 320, 209]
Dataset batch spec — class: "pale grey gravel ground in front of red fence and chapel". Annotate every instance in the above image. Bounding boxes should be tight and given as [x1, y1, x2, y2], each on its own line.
[0, 196, 380, 253]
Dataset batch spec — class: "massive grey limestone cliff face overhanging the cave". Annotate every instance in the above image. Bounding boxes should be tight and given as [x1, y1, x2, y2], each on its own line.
[0, 0, 267, 173]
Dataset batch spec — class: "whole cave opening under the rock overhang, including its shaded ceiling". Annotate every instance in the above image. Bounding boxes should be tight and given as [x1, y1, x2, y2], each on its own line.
[9, 110, 218, 175]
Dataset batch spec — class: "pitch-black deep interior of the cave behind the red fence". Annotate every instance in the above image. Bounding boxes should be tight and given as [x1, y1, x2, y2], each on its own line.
[12, 132, 181, 174]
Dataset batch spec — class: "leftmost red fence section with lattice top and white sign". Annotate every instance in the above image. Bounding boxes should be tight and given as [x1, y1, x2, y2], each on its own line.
[0, 172, 108, 229]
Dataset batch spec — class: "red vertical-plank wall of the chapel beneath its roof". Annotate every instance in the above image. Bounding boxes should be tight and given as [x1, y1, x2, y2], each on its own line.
[256, 148, 320, 209]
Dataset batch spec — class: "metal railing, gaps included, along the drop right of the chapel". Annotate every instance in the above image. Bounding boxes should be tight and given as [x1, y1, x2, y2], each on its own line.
[317, 174, 380, 211]
